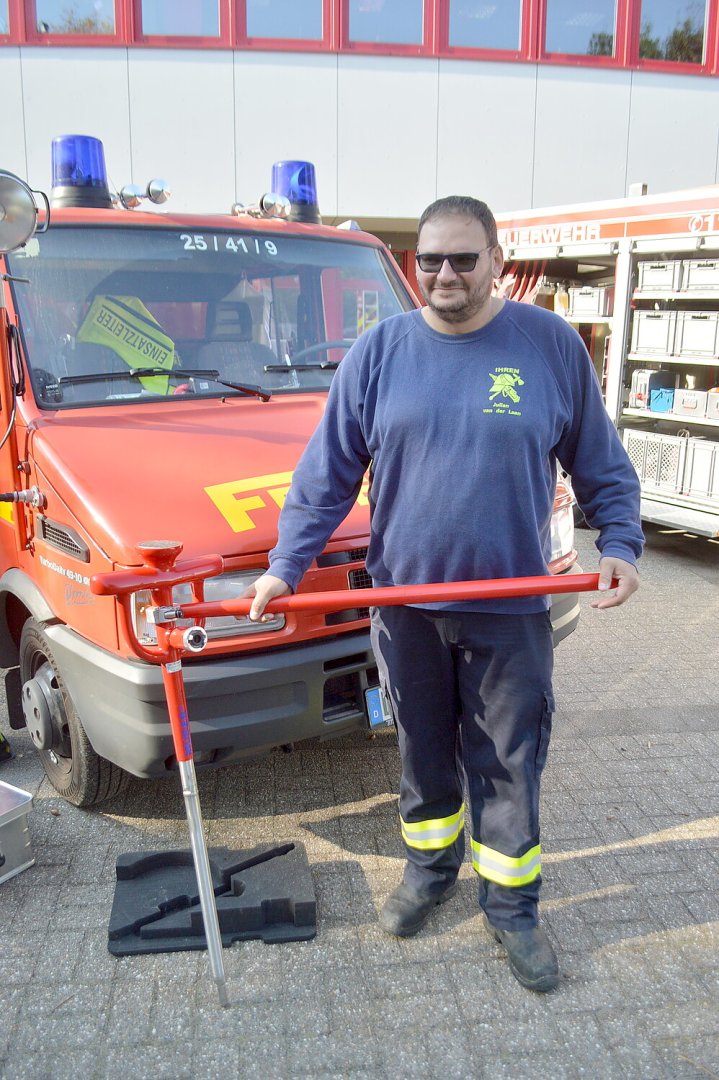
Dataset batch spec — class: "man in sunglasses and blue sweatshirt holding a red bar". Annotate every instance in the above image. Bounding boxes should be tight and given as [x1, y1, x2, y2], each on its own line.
[250, 195, 643, 991]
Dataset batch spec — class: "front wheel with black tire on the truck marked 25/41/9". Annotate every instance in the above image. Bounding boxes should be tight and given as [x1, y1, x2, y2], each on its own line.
[19, 619, 128, 807]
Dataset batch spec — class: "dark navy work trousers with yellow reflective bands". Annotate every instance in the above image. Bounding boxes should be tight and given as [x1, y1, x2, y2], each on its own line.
[372, 607, 554, 930]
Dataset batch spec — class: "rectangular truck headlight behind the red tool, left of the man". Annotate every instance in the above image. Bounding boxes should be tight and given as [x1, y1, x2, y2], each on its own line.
[133, 570, 285, 645]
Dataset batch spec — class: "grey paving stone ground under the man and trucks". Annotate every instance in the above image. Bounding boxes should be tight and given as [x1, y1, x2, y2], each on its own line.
[0, 526, 719, 1080]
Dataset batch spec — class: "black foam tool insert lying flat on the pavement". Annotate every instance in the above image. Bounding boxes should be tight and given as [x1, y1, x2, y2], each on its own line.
[108, 843, 317, 956]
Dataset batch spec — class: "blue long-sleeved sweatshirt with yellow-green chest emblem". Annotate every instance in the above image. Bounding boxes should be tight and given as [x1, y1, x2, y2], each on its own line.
[270, 300, 643, 612]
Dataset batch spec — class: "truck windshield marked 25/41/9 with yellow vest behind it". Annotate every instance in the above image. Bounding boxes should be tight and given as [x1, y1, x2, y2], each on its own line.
[8, 226, 412, 409]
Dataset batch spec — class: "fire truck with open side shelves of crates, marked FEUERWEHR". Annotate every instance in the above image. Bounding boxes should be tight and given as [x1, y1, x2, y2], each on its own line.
[490, 186, 719, 537]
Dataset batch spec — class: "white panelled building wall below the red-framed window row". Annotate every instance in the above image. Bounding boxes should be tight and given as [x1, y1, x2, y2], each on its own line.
[0, 46, 719, 228]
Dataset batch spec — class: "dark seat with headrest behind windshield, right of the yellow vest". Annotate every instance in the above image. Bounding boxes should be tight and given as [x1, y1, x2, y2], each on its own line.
[198, 300, 277, 387]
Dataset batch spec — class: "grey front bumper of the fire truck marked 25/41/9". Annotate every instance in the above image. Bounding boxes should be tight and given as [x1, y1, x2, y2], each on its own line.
[45, 625, 377, 777]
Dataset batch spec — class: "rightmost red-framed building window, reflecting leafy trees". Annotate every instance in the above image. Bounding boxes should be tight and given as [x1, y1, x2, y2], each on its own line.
[639, 0, 706, 64]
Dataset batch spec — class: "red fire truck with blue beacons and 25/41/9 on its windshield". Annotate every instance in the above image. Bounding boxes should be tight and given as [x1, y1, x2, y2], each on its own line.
[0, 137, 579, 806]
